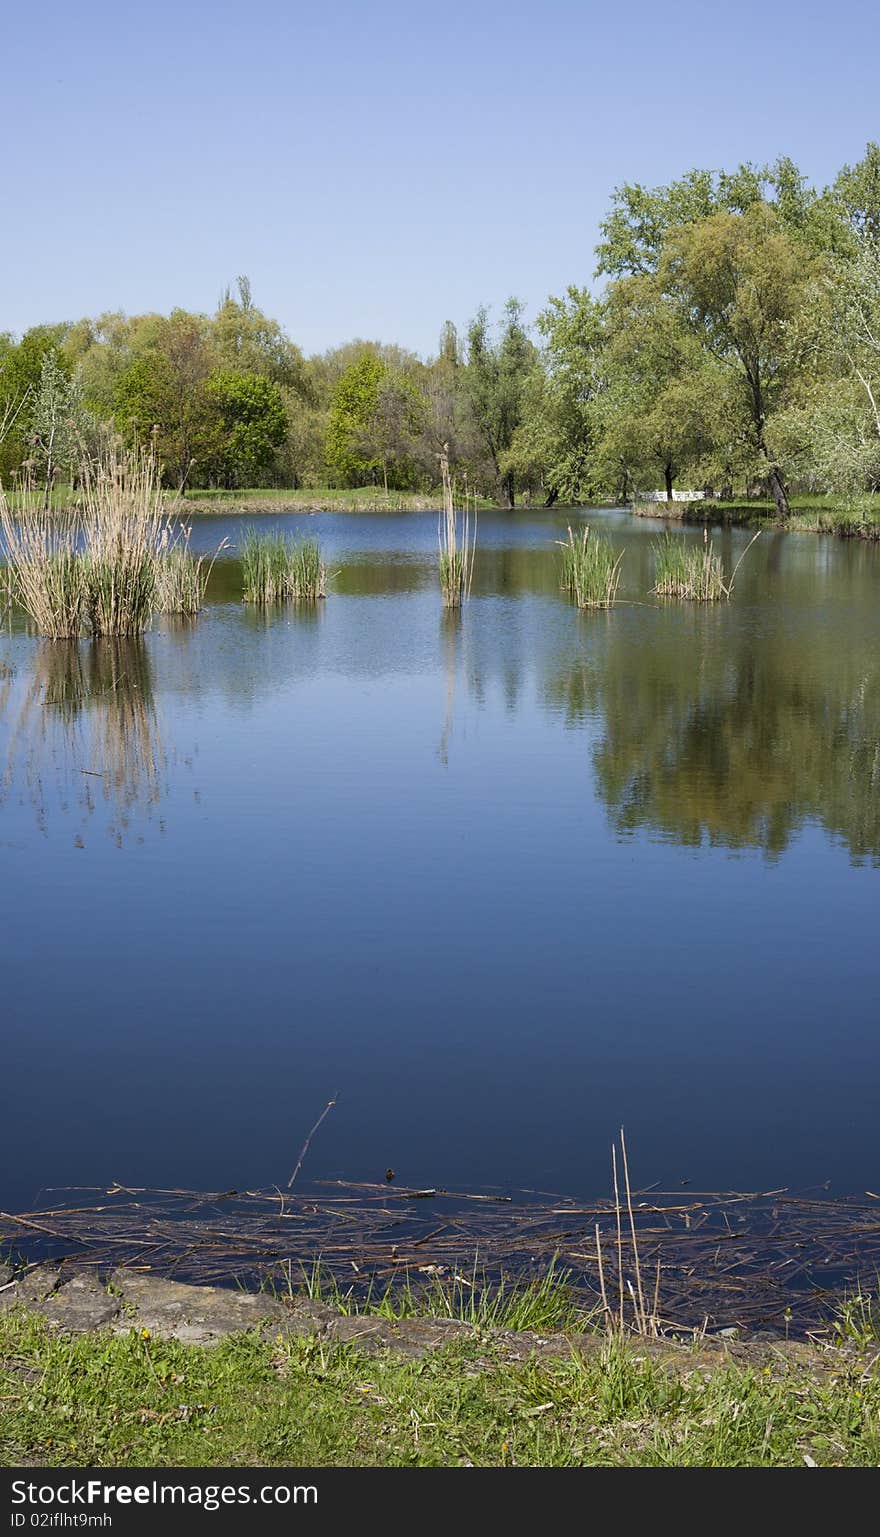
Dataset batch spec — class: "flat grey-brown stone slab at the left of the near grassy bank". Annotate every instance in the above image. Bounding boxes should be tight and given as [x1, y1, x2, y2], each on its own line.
[112, 1270, 291, 1345]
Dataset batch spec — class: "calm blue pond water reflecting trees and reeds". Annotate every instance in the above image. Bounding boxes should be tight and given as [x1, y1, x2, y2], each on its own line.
[0, 512, 880, 1210]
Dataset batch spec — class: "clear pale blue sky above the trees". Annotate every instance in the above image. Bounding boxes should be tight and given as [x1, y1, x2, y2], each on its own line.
[0, 0, 880, 352]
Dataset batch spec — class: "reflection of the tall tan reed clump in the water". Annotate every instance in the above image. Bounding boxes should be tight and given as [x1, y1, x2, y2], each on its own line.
[0, 639, 167, 845]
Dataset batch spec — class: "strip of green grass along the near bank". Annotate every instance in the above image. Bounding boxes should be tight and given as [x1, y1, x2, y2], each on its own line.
[0, 1314, 880, 1468]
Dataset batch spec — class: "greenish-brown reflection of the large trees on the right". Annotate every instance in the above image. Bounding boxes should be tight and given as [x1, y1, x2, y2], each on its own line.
[545, 613, 880, 864]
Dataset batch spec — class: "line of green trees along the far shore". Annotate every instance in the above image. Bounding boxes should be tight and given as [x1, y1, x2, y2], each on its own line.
[0, 144, 880, 518]
